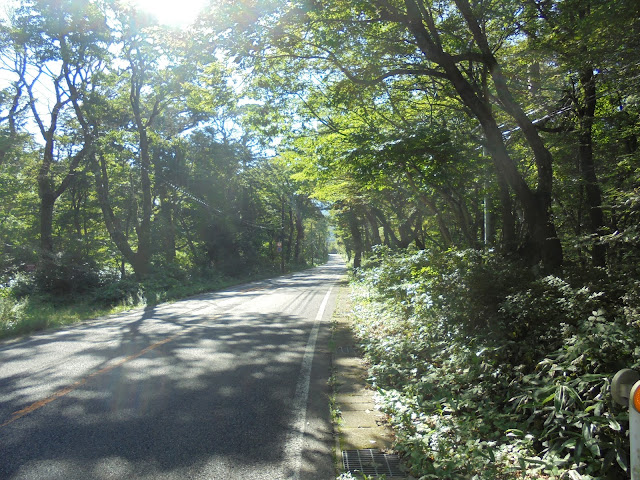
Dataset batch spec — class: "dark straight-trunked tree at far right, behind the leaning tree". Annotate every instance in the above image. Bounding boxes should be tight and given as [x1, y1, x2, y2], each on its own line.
[524, 0, 638, 267]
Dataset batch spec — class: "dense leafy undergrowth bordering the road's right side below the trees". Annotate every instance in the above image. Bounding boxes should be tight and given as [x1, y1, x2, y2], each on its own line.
[352, 248, 640, 480]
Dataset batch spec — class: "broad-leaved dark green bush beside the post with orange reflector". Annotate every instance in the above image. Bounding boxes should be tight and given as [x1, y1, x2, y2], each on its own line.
[511, 310, 640, 480]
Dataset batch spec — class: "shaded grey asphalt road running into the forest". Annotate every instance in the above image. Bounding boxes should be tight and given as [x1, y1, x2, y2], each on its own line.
[0, 256, 344, 480]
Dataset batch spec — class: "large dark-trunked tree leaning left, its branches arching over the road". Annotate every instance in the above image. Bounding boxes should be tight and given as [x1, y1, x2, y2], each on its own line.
[216, 0, 562, 269]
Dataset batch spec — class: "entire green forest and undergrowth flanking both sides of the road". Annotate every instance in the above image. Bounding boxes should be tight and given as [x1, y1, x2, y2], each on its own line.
[0, 0, 640, 478]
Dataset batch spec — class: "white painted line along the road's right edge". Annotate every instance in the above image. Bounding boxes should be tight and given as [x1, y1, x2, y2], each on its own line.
[287, 286, 333, 480]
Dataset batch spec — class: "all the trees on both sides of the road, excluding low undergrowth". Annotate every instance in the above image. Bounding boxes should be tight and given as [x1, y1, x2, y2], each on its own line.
[0, 0, 640, 292]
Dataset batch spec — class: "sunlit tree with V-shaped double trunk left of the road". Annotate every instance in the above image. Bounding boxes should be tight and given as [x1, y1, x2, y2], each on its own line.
[86, 10, 198, 278]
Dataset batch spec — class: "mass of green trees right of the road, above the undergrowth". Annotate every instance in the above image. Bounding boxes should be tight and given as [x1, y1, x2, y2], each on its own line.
[202, 0, 639, 272]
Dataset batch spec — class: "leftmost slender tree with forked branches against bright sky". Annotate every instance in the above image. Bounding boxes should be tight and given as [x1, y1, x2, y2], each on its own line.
[5, 0, 109, 284]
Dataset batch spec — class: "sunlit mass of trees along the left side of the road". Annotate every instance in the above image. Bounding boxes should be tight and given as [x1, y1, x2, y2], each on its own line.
[0, 0, 327, 302]
